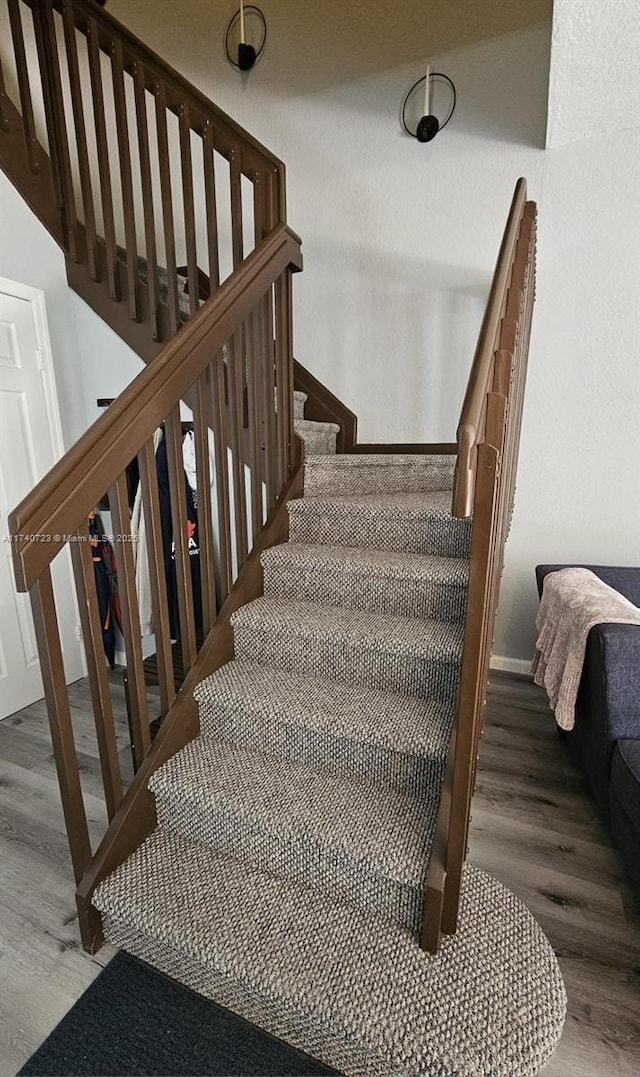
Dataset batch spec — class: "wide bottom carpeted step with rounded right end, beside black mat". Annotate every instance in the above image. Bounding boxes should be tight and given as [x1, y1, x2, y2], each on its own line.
[94, 828, 566, 1077]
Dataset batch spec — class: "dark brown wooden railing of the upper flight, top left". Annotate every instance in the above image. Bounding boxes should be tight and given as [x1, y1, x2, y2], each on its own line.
[0, 0, 286, 359]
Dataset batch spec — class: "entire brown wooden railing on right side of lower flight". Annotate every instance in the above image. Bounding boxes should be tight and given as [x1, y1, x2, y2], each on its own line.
[422, 180, 535, 952]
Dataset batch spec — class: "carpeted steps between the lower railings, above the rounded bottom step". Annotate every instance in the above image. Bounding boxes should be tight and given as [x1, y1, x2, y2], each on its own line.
[95, 456, 463, 940]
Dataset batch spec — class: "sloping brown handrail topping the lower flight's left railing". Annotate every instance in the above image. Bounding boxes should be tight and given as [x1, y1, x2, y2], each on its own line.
[9, 224, 302, 591]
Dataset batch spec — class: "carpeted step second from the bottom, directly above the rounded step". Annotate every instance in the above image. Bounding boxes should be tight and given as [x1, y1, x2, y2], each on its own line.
[150, 738, 436, 932]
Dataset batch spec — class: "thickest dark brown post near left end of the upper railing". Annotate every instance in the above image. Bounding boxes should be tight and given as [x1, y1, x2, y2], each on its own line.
[32, 3, 79, 262]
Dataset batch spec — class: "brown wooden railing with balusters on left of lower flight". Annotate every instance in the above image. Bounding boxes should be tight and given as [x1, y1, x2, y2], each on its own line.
[10, 224, 302, 948]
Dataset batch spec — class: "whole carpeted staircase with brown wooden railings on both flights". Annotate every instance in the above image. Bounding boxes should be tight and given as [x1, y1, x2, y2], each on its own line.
[0, 0, 548, 1075]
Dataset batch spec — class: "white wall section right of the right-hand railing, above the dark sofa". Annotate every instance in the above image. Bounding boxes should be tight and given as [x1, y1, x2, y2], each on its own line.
[496, 131, 640, 658]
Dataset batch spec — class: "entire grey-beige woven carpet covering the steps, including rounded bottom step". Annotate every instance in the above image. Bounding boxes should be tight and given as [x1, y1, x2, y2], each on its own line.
[95, 394, 565, 1077]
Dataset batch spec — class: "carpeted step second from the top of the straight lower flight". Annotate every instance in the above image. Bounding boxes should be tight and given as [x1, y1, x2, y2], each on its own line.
[287, 490, 471, 558]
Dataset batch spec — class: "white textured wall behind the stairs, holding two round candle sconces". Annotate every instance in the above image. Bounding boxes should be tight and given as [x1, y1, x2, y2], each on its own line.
[110, 0, 640, 662]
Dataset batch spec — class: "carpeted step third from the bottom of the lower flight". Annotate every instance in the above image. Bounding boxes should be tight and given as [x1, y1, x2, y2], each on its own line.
[194, 661, 455, 800]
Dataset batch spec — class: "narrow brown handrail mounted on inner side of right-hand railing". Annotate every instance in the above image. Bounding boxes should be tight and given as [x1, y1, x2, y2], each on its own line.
[453, 179, 527, 518]
